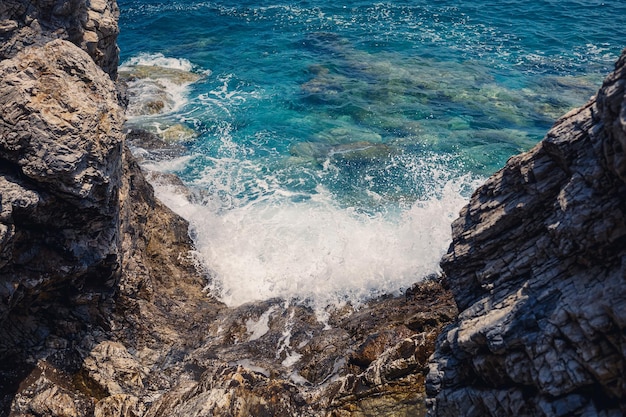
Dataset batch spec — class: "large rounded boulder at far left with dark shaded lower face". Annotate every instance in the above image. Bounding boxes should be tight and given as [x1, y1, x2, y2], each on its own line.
[0, 40, 124, 378]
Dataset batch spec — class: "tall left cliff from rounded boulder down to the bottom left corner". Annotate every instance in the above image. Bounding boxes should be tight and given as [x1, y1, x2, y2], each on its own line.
[0, 6, 222, 416]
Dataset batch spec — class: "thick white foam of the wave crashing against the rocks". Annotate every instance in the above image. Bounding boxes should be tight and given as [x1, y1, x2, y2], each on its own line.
[149, 167, 476, 311]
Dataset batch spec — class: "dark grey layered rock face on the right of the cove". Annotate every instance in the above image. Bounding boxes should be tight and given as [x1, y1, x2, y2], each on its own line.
[427, 52, 626, 416]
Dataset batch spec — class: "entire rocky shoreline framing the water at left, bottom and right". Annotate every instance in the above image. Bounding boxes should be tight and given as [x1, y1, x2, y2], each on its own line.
[0, 0, 626, 417]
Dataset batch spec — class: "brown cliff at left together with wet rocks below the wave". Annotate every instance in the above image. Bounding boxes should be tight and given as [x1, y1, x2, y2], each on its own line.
[0, 0, 456, 417]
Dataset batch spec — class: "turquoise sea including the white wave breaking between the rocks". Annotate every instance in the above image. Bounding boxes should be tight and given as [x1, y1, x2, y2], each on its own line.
[118, 0, 626, 308]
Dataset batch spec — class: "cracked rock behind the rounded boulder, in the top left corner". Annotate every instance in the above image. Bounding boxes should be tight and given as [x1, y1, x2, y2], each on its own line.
[0, 0, 119, 79]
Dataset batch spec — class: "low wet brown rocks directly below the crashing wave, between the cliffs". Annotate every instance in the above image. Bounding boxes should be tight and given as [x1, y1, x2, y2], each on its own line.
[135, 279, 456, 417]
